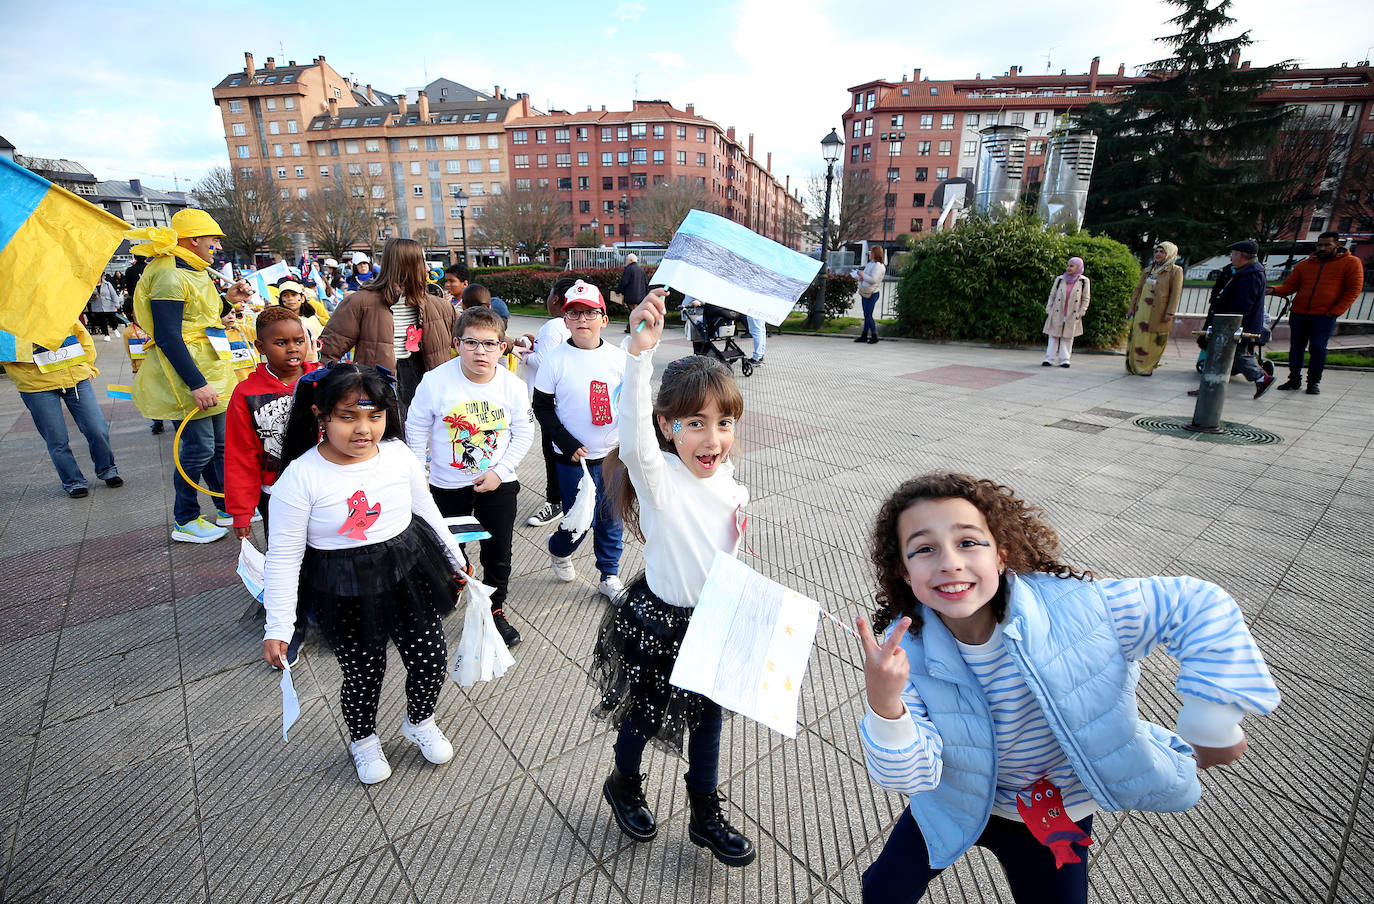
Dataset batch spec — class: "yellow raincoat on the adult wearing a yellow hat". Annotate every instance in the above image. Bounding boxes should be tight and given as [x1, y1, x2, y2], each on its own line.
[133, 254, 238, 420]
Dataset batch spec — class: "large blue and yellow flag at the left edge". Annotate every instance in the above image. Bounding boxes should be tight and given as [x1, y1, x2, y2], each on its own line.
[0, 157, 131, 349]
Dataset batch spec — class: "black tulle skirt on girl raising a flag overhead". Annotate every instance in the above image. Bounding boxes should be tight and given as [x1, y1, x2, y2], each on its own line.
[591, 574, 709, 753]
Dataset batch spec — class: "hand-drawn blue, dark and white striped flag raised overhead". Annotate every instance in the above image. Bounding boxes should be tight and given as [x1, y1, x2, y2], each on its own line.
[653, 210, 820, 324]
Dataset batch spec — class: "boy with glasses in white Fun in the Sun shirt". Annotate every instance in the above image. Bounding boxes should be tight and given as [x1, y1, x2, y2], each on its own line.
[405, 308, 534, 647]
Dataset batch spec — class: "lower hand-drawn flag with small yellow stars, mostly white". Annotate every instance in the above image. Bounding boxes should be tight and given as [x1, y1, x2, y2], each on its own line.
[669, 552, 820, 738]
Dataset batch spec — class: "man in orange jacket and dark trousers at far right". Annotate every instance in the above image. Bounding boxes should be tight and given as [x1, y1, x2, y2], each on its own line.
[1267, 232, 1364, 396]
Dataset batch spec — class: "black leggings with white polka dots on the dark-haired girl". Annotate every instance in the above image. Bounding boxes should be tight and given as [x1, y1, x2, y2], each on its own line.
[334, 615, 448, 741]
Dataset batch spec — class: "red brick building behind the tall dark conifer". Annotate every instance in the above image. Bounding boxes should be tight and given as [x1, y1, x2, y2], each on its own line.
[842, 58, 1374, 240]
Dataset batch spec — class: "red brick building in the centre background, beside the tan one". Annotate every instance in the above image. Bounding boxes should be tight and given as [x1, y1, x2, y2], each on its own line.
[506, 100, 801, 247]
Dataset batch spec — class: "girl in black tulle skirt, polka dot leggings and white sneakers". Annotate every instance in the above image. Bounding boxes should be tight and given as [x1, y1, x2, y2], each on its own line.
[262, 364, 466, 784]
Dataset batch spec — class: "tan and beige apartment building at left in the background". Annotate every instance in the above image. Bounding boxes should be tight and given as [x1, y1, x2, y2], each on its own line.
[213, 54, 537, 257]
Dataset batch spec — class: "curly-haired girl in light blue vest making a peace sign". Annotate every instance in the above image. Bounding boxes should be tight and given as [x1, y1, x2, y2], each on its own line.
[859, 474, 1279, 903]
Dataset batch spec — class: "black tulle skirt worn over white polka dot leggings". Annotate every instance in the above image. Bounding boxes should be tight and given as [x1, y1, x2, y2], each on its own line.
[300, 518, 462, 650]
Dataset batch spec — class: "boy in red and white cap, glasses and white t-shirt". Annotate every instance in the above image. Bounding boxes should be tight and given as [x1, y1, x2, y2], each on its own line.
[534, 280, 627, 599]
